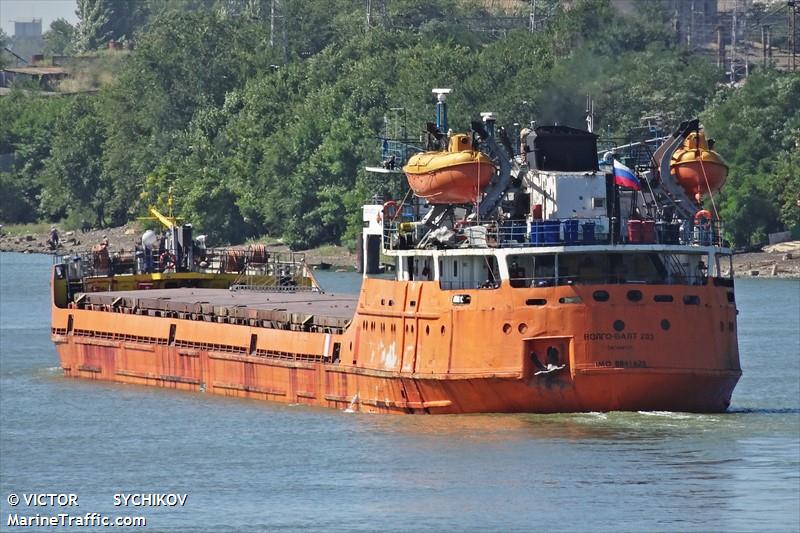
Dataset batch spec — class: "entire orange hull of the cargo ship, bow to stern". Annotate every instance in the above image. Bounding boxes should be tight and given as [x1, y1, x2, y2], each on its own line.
[52, 279, 741, 413]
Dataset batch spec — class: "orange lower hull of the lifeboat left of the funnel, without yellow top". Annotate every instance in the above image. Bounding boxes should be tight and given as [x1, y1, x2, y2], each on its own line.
[406, 162, 494, 204]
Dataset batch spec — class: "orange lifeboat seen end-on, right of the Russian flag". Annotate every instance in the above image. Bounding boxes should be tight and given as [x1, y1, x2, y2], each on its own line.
[670, 131, 728, 201]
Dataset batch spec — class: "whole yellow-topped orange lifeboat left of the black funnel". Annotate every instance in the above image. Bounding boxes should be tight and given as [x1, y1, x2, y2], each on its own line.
[403, 134, 495, 204]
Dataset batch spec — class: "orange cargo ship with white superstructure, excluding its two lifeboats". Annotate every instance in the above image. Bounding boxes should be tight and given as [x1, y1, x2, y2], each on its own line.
[52, 101, 741, 413]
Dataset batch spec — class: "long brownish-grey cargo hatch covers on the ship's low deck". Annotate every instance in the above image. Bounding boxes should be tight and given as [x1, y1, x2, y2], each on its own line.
[76, 288, 358, 331]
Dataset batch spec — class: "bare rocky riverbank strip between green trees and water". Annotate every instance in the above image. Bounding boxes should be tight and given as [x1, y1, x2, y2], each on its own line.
[0, 223, 800, 279]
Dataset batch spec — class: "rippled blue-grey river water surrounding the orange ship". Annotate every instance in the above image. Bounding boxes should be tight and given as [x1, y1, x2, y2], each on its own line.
[0, 253, 800, 532]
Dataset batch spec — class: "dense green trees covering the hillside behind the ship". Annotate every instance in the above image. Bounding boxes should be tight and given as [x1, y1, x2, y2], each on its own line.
[0, 0, 800, 248]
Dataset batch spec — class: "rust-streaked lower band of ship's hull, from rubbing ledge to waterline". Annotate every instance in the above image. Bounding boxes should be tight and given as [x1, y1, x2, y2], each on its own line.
[50, 337, 740, 414]
